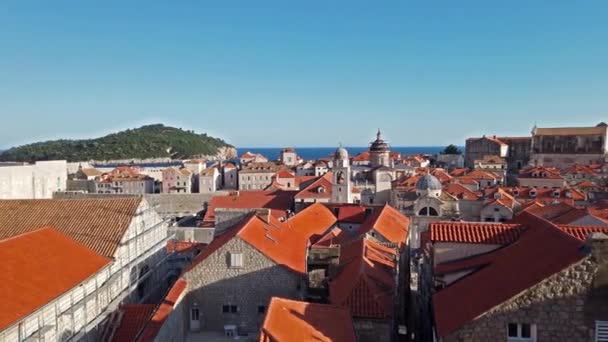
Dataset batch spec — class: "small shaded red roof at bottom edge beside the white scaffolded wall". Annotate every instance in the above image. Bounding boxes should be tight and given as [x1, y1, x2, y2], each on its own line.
[112, 304, 156, 342]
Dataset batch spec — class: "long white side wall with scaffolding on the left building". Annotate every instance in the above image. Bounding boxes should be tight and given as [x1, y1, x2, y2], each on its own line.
[0, 200, 167, 342]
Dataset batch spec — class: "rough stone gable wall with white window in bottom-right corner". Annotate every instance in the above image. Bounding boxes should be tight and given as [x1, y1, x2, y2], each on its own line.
[441, 258, 606, 342]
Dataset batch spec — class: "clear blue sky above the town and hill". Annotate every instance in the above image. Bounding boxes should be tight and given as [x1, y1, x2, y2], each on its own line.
[0, 0, 608, 148]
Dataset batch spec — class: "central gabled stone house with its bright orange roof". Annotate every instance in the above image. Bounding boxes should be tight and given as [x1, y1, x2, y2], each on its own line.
[147, 204, 336, 340]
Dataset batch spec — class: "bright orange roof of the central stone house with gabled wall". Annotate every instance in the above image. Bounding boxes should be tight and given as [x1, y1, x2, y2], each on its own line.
[190, 203, 336, 273]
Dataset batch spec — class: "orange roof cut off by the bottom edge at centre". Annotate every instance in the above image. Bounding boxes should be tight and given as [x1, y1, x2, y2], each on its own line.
[260, 297, 356, 342]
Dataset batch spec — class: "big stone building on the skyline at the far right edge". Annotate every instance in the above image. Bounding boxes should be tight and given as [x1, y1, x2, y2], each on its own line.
[531, 122, 608, 169]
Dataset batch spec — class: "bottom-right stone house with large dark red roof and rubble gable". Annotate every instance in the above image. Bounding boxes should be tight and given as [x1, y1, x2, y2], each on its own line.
[432, 213, 608, 342]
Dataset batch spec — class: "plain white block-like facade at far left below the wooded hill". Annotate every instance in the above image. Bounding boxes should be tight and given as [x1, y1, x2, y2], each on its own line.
[0, 160, 68, 199]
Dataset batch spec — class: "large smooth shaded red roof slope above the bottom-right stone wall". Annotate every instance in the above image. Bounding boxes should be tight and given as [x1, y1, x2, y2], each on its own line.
[433, 213, 583, 337]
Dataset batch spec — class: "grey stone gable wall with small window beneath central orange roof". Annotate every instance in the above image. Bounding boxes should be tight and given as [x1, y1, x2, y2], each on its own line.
[183, 237, 303, 332]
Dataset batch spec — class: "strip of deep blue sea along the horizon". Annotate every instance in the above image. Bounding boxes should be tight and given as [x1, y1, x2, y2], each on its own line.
[237, 146, 454, 160]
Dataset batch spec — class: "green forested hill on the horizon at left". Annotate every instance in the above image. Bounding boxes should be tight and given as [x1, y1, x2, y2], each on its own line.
[0, 124, 231, 161]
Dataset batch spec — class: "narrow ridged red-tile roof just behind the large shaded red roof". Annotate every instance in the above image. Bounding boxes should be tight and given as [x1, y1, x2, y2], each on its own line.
[429, 221, 524, 245]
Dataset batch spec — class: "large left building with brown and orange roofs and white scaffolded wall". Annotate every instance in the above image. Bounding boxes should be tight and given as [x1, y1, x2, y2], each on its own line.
[0, 197, 168, 341]
